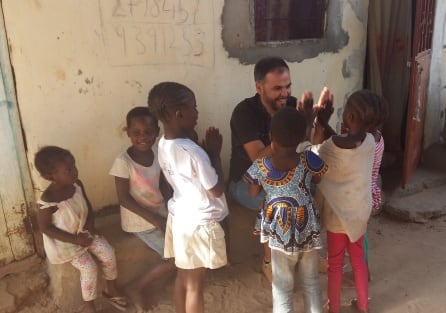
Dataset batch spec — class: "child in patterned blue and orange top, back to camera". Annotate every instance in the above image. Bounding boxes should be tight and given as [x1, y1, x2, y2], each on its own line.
[244, 107, 327, 313]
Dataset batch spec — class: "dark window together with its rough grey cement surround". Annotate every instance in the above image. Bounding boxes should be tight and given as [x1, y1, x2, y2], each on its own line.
[221, 0, 346, 64]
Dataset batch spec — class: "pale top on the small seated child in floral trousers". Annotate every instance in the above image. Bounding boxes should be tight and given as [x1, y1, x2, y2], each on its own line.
[37, 184, 88, 264]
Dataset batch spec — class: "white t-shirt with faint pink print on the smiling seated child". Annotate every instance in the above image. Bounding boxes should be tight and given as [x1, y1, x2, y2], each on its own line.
[109, 148, 164, 233]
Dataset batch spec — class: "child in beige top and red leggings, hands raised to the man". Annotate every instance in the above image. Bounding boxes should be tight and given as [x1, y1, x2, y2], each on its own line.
[311, 90, 381, 313]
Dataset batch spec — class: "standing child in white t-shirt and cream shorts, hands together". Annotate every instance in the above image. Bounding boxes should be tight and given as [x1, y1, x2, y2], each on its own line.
[148, 82, 228, 313]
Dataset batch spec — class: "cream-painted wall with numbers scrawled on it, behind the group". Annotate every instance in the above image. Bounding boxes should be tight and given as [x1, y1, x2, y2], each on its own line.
[2, 0, 368, 208]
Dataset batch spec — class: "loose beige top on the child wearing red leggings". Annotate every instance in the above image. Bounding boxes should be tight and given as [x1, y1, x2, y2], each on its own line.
[307, 133, 375, 242]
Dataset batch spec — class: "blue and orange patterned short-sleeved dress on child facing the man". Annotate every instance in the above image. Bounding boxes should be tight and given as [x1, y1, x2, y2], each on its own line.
[244, 151, 328, 254]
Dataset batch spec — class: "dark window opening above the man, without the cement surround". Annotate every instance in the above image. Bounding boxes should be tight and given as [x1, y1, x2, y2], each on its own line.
[254, 0, 326, 42]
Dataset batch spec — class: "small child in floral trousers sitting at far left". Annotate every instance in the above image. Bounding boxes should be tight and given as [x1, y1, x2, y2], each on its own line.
[34, 146, 127, 313]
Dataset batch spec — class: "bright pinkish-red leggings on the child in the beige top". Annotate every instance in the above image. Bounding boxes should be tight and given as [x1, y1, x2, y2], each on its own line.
[327, 231, 368, 313]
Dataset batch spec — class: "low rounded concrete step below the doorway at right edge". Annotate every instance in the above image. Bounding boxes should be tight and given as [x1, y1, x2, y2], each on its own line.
[383, 185, 446, 223]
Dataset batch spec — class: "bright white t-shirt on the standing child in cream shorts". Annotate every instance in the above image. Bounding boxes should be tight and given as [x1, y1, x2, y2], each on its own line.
[158, 136, 228, 226]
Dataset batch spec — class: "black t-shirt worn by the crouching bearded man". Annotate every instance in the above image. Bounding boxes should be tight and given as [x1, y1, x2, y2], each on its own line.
[229, 94, 297, 181]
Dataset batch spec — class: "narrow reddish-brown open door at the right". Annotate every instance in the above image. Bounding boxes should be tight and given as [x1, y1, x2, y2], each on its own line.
[402, 0, 435, 187]
